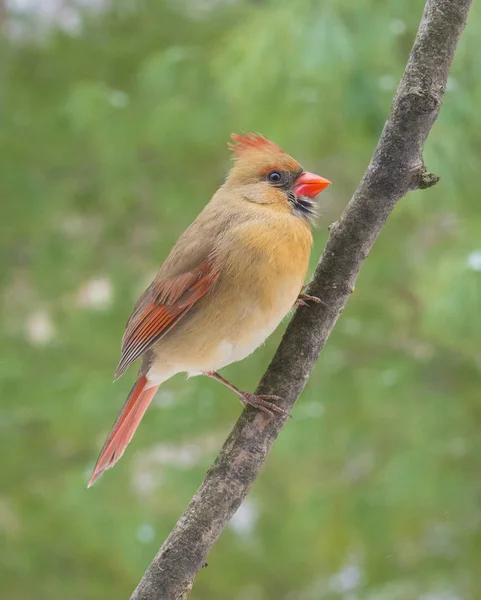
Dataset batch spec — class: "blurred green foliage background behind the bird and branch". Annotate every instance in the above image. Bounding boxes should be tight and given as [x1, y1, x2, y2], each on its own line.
[0, 0, 481, 600]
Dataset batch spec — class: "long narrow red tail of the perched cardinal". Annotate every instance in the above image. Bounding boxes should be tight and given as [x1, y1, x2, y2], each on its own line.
[88, 375, 159, 487]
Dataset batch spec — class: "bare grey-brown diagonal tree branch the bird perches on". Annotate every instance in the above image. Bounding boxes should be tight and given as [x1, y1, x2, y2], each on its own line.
[131, 0, 471, 600]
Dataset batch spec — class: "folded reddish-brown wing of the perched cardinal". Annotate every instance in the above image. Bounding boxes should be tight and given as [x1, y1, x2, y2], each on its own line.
[115, 258, 219, 379]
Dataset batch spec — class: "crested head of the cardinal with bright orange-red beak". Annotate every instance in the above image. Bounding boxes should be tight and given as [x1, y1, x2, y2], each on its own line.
[226, 133, 331, 219]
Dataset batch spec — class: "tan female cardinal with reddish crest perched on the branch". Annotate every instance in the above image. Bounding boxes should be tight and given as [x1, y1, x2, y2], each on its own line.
[88, 133, 331, 487]
